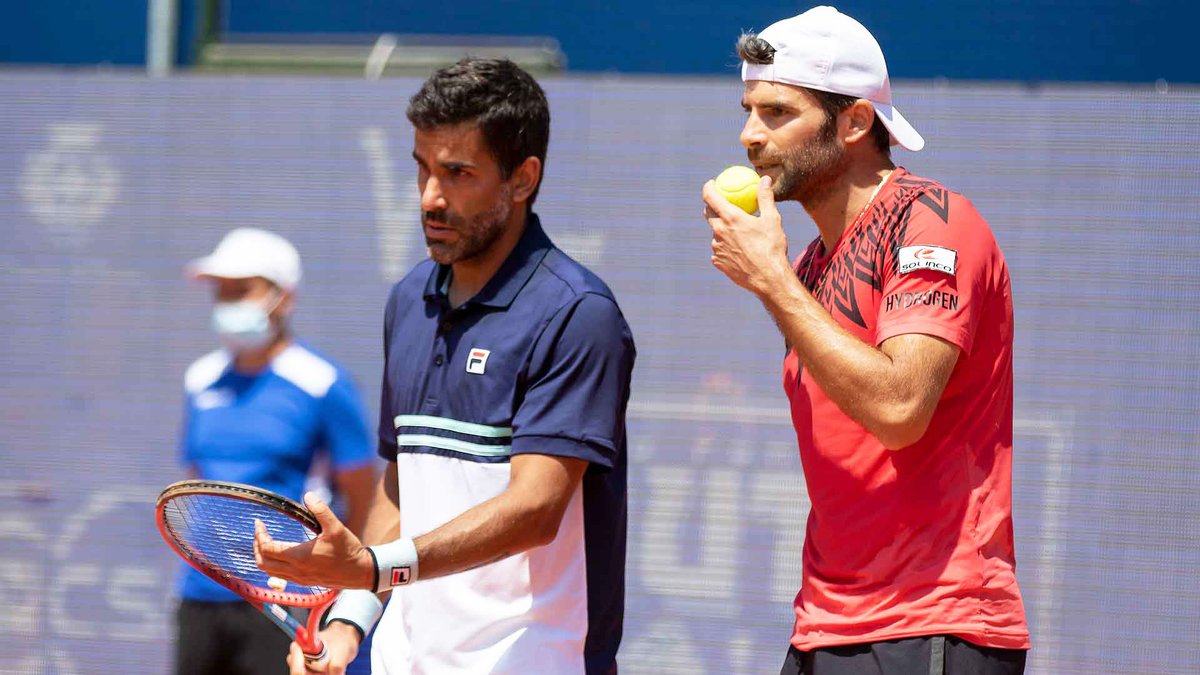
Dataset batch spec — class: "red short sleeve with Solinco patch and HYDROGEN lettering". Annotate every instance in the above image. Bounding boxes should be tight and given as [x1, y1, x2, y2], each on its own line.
[875, 189, 998, 353]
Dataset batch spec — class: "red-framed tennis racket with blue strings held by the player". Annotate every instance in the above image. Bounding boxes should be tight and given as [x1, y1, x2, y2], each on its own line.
[155, 480, 338, 667]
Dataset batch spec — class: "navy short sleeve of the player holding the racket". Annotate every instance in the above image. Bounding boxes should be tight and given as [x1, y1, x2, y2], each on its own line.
[512, 293, 636, 468]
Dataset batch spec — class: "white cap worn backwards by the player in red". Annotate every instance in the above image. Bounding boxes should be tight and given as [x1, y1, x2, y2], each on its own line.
[742, 6, 925, 151]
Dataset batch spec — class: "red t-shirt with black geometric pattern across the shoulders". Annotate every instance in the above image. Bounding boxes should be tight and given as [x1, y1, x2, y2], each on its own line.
[784, 168, 1030, 650]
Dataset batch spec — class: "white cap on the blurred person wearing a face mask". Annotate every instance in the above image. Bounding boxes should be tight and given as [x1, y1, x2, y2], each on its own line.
[186, 227, 301, 291]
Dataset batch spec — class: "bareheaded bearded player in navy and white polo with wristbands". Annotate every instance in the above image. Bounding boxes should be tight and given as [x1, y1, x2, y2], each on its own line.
[256, 59, 635, 675]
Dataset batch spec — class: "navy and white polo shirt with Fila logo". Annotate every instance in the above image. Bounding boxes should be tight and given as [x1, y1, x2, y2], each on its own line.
[372, 214, 635, 675]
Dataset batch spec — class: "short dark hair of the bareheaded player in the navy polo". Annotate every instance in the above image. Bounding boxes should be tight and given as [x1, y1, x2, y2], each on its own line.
[406, 58, 550, 208]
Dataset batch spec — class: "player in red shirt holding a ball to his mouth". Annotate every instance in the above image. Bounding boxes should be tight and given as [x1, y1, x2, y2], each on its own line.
[703, 7, 1030, 675]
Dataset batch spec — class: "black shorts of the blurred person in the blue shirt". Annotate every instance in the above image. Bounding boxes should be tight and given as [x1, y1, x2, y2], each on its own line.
[175, 601, 292, 675]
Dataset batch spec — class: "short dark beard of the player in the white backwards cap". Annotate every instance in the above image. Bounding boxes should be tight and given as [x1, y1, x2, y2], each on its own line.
[750, 117, 848, 207]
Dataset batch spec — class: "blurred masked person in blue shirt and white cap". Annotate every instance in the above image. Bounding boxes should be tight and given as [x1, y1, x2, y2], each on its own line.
[175, 228, 377, 675]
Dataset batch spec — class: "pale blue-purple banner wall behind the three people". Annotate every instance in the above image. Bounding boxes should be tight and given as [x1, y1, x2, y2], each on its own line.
[0, 72, 1200, 675]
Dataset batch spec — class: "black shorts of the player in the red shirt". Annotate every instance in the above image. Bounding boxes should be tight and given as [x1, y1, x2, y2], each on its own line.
[779, 635, 1026, 675]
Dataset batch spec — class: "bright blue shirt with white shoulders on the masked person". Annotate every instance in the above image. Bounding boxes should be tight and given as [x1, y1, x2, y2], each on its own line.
[180, 342, 376, 602]
